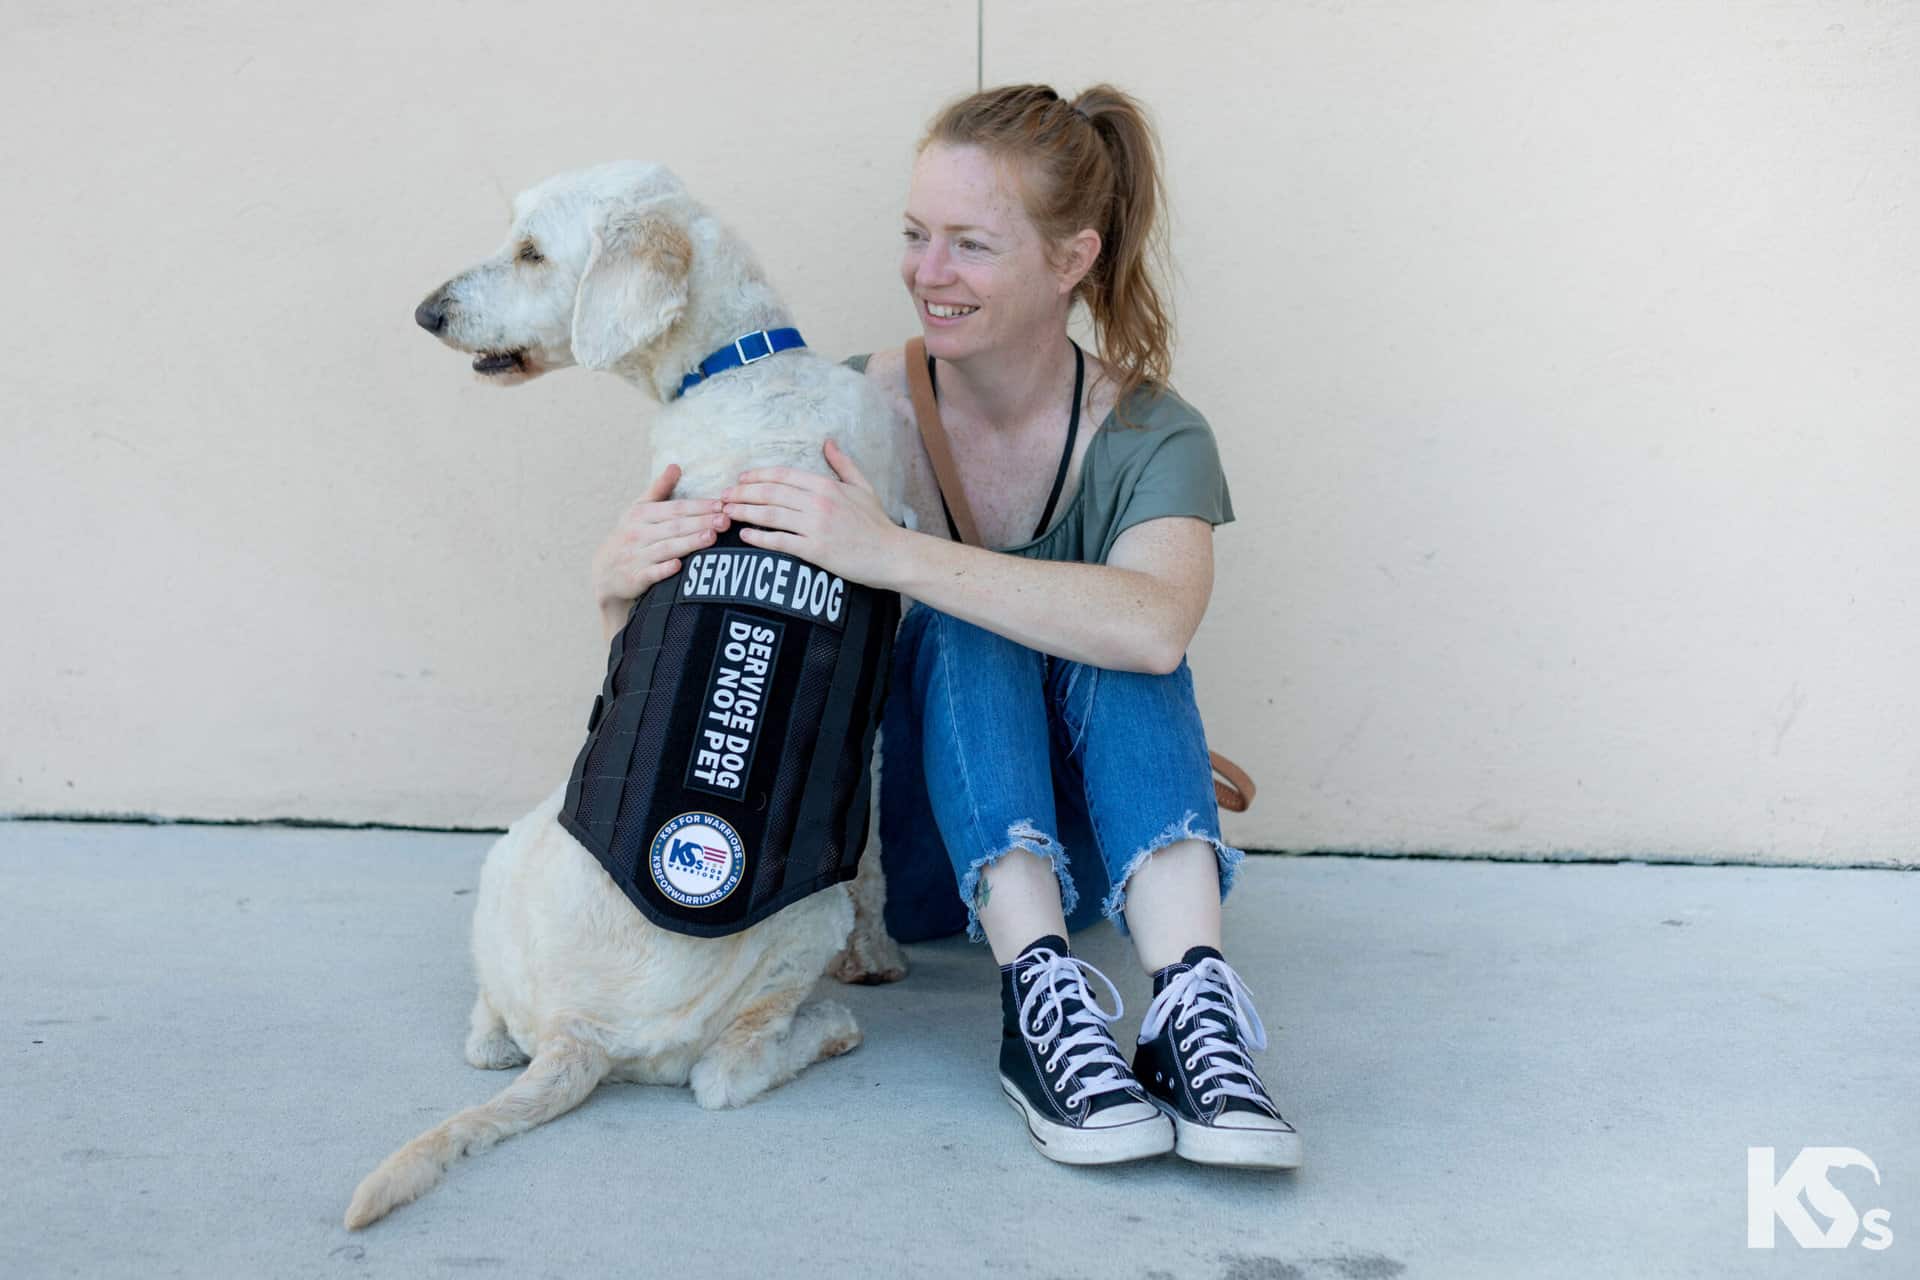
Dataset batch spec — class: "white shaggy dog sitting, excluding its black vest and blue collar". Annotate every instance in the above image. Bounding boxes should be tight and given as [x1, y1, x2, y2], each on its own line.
[346, 163, 912, 1228]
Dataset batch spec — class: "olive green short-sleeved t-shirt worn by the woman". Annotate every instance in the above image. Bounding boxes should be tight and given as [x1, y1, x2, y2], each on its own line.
[845, 355, 1233, 564]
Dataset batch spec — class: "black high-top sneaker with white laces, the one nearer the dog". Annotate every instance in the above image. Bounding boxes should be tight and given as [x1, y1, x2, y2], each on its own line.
[1000, 935, 1173, 1165]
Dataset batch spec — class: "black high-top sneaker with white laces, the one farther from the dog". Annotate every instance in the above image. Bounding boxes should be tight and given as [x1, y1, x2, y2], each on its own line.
[1133, 946, 1302, 1169]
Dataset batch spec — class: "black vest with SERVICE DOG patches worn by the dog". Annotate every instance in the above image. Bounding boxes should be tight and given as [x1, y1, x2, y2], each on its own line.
[561, 526, 900, 936]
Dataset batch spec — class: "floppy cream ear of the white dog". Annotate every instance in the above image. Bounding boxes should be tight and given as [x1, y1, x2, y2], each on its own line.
[572, 207, 693, 368]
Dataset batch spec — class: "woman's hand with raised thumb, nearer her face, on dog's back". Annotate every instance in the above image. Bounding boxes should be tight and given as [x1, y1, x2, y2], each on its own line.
[720, 439, 904, 587]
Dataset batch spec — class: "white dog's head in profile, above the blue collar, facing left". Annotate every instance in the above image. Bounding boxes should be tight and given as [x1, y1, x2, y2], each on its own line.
[413, 163, 695, 386]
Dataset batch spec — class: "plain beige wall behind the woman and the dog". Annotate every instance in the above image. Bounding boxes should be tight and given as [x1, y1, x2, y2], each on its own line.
[0, 0, 1920, 862]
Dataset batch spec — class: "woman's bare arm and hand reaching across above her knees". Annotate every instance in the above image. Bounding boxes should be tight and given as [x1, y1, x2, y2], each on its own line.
[720, 441, 1213, 674]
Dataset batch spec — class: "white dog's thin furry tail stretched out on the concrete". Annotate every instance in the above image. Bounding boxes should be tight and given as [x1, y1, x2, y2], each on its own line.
[346, 1031, 612, 1230]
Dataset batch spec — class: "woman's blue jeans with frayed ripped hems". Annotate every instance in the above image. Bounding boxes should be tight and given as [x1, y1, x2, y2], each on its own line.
[879, 603, 1242, 942]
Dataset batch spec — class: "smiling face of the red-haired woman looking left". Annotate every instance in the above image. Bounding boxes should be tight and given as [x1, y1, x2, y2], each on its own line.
[900, 142, 1079, 361]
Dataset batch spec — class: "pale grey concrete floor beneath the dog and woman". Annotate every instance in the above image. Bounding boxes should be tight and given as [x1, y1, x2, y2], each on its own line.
[0, 821, 1920, 1280]
